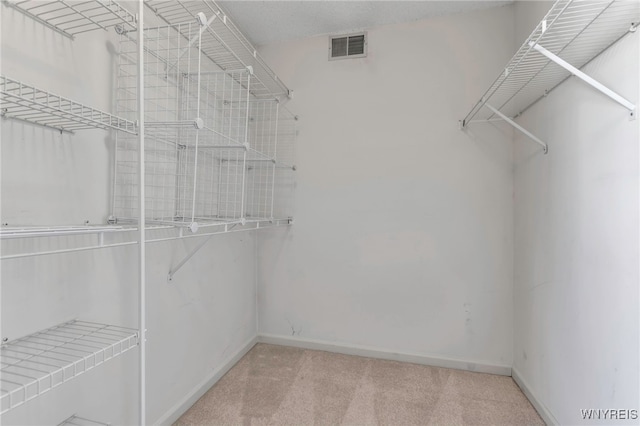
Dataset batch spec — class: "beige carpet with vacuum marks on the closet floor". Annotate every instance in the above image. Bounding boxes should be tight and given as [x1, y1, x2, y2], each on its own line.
[175, 344, 544, 425]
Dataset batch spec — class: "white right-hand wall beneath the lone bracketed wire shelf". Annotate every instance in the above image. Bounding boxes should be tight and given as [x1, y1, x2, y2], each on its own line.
[514, 2, 640, 424]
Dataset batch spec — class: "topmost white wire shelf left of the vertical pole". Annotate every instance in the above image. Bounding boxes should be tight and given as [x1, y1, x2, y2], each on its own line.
[3, 0, 136, 38]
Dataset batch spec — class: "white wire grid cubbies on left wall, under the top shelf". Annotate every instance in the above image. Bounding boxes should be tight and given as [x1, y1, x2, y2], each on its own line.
[112, 15, 296, 233]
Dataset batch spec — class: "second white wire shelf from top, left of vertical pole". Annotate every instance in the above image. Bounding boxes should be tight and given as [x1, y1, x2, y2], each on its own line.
[0, 76, 137, 134]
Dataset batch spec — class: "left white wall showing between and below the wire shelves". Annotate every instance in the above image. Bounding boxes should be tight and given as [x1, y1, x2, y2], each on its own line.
[0, 5, 257, 424]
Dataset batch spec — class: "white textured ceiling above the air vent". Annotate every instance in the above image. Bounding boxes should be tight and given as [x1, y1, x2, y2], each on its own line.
[217, 0, 512, 45]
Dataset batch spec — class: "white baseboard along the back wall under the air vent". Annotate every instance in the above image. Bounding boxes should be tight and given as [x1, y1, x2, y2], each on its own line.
[258, 334, 511, 376]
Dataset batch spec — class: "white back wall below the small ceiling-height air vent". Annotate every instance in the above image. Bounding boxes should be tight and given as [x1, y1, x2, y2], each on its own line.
[259, 6, 514, 368]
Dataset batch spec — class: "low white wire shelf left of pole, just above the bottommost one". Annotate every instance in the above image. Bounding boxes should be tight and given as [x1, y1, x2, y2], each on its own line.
[0, 320, 138, 413]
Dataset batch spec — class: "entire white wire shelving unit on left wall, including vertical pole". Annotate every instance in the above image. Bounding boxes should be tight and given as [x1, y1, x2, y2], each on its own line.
[0, 0, 297, 425]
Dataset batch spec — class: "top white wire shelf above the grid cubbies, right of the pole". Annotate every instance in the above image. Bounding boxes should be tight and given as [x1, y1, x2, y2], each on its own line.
[145, 0, 290, 98]
